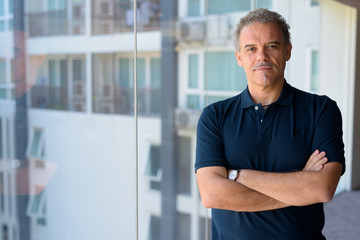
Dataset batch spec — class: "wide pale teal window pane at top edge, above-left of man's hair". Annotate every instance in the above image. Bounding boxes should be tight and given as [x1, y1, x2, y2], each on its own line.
[208, 0, 251, 14]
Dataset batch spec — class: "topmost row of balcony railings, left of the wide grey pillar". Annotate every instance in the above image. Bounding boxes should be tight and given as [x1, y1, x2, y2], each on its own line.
[27, 0, 160, 37]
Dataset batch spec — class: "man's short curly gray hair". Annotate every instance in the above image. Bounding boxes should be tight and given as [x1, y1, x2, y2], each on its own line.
[233, 8, 291, 52]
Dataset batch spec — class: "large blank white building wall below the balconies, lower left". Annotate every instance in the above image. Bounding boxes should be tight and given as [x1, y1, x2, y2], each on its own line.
[29, 110, 160, 240]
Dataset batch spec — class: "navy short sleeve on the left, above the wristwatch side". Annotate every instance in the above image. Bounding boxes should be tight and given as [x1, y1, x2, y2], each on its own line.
[195, 105, 227, 172]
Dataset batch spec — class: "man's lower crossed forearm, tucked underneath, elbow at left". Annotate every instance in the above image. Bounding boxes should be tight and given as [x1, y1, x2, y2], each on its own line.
[197, 167, 289, 212]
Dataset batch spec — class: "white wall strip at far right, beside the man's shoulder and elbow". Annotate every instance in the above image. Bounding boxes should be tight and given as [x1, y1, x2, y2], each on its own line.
[319, 0, 356, 191]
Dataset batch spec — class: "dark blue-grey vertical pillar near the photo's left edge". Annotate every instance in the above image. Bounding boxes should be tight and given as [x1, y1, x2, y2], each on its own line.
[13, 0, 30, 240]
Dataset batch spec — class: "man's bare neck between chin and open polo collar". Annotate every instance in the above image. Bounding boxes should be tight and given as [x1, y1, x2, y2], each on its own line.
[249, 80, 284, 105]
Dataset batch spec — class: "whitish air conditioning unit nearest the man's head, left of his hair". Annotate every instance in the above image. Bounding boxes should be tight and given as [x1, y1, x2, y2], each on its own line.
[207, 16, 231, 41]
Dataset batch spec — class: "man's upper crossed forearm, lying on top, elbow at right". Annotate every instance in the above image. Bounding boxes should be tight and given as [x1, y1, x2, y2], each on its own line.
[237, 163, 340, 206]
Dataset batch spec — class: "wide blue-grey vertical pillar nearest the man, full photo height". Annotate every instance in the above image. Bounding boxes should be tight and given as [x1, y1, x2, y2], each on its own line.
[160, 0, 178, 240]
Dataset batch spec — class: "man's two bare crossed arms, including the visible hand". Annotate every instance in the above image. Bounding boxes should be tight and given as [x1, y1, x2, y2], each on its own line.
[197, 151, 342, 212]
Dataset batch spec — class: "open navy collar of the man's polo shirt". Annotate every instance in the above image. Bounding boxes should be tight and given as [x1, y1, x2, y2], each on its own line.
[241, 80, 294, 108]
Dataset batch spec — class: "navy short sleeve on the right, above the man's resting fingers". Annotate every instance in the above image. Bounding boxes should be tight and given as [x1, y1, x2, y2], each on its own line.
[312, 99, 345, 173]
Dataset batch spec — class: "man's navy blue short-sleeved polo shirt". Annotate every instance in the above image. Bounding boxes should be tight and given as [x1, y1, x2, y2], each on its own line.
[195, 82, 345, 240]
